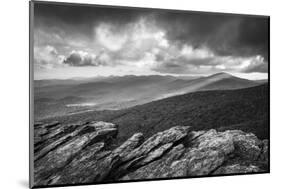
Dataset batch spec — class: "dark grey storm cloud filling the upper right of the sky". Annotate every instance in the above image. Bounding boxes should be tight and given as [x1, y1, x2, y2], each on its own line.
[154, 12, 269, 60]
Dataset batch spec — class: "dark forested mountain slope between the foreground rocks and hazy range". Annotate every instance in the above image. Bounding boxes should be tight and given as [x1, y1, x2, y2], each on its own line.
[41, 84, 269, 141]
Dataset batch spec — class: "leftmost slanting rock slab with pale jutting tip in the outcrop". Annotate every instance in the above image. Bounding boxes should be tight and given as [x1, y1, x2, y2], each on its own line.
[35, 122, 117, 184]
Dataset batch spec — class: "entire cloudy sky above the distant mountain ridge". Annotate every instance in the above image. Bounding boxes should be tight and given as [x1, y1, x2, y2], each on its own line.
[31, 3, 269, 79]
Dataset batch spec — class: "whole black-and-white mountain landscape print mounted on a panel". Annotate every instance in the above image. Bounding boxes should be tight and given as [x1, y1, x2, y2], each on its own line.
[30, 1, 269, 187]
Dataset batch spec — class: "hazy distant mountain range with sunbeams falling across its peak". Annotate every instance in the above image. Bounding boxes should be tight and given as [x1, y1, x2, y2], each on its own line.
[34, 73, 267, 119]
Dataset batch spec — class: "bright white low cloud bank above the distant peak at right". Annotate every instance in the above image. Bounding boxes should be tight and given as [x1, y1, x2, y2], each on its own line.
[152, 45, 268, 74]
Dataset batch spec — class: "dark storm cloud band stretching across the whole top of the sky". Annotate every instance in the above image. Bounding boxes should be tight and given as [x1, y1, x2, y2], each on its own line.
[35, 3, 269, 59]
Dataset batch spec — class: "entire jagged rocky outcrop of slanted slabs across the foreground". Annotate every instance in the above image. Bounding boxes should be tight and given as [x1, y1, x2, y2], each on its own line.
[34, 121, 268, 186]
